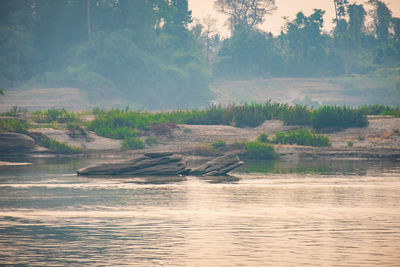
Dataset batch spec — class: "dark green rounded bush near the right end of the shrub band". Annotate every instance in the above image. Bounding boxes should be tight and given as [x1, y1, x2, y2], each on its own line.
[311, 106, 368, 129]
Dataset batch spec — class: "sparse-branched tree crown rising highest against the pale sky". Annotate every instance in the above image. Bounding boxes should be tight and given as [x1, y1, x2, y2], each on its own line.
[215, 0, 276, 29]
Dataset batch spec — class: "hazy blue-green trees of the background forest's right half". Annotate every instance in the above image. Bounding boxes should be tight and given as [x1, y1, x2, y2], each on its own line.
[214, 0, 400, 78]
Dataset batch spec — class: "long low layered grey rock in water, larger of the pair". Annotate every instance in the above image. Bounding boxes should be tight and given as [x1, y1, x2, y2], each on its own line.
[77, 152, 186, 175]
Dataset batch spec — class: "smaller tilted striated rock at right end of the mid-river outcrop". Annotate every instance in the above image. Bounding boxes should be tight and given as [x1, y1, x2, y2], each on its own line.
[189, 154, 243, 176]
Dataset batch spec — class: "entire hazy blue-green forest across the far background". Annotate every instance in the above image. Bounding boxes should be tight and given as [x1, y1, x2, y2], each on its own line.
[0, 0, 400, 109]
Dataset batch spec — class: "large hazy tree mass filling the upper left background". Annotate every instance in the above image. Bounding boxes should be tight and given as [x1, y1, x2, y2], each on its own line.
[0, 0, 210, 108]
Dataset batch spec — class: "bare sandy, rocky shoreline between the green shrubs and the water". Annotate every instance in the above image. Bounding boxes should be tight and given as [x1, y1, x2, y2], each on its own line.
[0, 116, 400, 165]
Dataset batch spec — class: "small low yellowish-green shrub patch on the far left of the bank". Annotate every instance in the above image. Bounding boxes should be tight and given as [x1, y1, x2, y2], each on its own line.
[31, 108, 79, 123]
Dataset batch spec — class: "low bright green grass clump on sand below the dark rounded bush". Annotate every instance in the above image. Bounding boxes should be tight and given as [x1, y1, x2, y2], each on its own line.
[272, 129, 331, 147]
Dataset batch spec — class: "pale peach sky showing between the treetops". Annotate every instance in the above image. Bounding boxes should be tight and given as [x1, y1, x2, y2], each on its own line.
[188, 0, 400, 35]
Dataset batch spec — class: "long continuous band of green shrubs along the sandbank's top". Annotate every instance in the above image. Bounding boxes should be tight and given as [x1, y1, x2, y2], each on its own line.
[87, 101, 382, 142]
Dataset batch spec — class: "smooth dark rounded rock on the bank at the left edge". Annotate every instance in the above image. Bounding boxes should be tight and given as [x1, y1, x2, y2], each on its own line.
[0, 132, 35, 154]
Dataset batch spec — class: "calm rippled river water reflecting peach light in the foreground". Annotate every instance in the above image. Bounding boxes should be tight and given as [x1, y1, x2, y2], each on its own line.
[0, 159, 400, 266]
